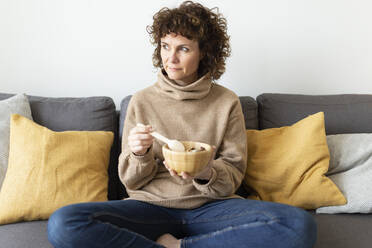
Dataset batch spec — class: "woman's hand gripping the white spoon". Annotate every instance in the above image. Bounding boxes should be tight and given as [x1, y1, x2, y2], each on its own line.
[128, 124, 154, 156]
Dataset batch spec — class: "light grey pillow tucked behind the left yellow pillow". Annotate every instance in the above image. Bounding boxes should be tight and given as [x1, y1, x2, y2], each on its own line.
[0, 94, 32, 189]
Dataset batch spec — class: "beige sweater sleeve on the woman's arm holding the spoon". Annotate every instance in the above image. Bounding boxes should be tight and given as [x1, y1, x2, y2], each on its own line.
[118, 96, 158, 190]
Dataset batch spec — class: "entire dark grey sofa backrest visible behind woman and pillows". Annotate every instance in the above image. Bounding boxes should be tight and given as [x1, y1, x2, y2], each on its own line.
[6, 93, 372, 200]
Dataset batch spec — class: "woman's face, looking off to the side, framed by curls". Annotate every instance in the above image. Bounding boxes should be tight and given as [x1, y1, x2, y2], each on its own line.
[160, 33, 201, 85]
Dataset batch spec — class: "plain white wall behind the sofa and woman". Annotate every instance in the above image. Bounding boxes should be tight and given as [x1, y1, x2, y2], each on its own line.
[0, 0, 372, 106]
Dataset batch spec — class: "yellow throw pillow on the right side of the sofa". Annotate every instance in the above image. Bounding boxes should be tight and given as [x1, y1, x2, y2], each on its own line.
[244, 112, 346, 209]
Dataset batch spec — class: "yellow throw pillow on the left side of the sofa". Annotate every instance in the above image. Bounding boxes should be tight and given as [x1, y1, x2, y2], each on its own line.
[0, 114, 114, 224]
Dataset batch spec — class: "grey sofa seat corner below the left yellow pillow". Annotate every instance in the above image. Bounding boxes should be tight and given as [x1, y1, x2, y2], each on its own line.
[0, 221, 53, 248]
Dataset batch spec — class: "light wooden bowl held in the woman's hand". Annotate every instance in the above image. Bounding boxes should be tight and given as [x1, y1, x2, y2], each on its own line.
[162, 141, 212, 176]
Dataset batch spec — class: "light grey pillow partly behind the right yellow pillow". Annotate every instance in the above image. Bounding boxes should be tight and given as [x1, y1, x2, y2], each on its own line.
[316, 133, 372, 214]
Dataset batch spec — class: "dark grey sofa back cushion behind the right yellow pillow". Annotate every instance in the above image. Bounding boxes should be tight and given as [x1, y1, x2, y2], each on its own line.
[257, 93, 372, 134]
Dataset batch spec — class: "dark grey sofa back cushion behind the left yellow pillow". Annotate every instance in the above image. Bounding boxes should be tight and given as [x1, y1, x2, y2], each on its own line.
[0, 93, 121, 200]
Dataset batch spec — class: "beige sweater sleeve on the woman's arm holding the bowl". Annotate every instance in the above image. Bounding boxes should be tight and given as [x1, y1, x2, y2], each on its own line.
[193, 101, 247, 197]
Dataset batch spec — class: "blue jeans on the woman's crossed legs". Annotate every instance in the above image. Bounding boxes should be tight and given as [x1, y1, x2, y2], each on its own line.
[48, 199, 316, 248]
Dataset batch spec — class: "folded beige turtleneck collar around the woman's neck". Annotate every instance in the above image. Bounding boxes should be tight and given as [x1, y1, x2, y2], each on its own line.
[155, 71, 212, 100]
